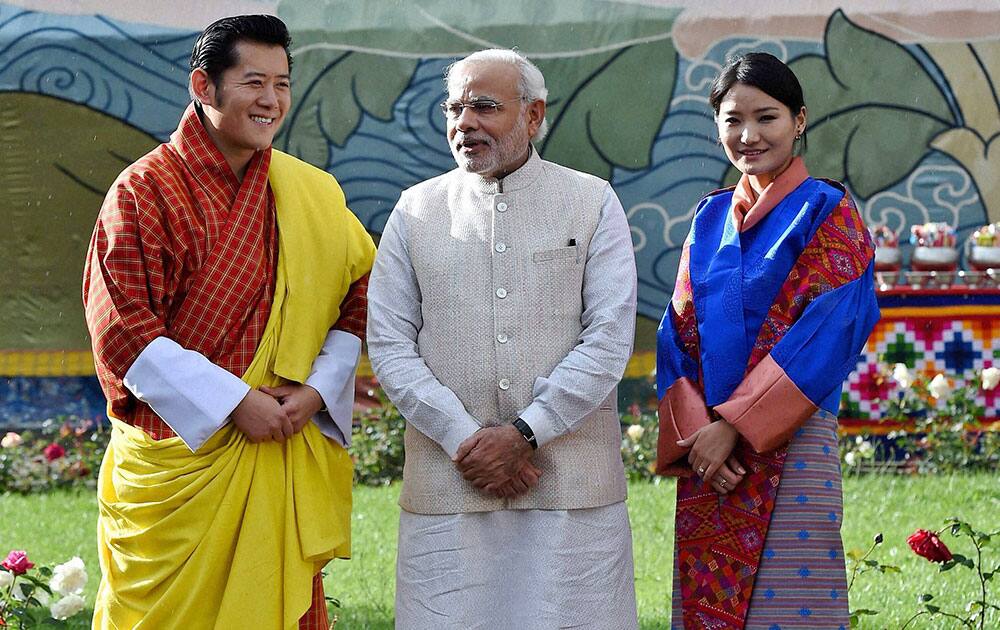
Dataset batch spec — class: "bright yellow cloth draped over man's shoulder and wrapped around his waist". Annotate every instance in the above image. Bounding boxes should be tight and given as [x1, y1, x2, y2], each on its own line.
[94, 139, 374, 629]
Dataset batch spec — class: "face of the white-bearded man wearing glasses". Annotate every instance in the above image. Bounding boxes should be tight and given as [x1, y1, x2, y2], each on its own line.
[447, 62, 545, 177]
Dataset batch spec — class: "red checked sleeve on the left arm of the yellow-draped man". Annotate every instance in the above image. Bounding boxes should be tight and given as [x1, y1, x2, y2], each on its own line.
[83, 182, 167, 380]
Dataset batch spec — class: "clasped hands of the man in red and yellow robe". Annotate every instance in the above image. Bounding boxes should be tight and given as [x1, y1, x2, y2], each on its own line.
[231, 383, 323, 443]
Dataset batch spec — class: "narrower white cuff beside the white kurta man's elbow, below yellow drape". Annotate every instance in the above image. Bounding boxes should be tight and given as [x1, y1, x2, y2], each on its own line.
[305, 330, 361, 446]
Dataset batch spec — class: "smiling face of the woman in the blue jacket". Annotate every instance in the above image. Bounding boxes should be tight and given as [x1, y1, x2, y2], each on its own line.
[715, 83, 806, 181]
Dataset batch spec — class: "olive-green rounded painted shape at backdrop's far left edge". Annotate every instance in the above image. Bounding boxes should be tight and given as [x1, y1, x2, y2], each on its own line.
[0, 92, 159, 350]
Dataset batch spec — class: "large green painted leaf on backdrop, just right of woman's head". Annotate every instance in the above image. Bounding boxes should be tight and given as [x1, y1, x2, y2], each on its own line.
[790, 10, 955, 198]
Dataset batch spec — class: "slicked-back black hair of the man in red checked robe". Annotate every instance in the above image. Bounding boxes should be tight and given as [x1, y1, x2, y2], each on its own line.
[191, 15, 292, 85]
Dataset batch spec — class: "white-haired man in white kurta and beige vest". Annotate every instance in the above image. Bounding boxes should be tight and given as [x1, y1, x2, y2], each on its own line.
[368, 50, 637, 630]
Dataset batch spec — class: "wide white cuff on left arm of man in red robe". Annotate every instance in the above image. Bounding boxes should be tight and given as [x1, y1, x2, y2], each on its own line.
[123, 337, 250, 452]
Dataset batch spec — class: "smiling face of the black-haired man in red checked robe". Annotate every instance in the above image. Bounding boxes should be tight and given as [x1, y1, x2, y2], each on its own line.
[191, 41, 292, 177]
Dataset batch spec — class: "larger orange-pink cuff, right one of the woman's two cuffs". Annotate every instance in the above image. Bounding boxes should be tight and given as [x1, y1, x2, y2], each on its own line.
[716, 355, 818, 453]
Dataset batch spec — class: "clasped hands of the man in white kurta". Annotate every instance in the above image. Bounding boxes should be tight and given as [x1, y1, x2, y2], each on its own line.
[453, 424, 542, 498]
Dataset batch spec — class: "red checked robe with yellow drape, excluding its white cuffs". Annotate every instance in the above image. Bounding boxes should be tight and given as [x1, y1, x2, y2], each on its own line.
[84, 106, 374, 628]
